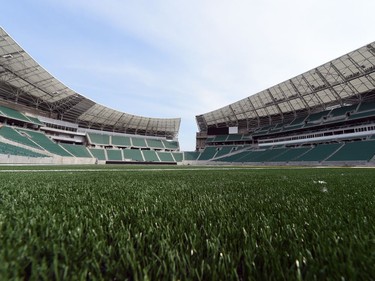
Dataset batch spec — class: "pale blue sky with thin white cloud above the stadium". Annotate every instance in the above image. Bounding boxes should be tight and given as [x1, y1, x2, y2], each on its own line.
[0, 0, 375, 150]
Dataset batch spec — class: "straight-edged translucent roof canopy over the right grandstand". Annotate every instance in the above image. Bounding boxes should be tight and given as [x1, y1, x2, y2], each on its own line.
[196, 42, 375, 131]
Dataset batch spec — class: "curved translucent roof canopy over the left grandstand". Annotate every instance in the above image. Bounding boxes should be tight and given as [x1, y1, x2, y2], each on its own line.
[0, 27, 181, 138]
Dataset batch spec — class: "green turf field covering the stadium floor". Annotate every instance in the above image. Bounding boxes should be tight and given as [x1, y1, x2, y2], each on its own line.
[0, 166, 375, 280]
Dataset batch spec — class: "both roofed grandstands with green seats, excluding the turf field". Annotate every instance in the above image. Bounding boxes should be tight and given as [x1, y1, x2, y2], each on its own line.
[0, 28, 375, 165]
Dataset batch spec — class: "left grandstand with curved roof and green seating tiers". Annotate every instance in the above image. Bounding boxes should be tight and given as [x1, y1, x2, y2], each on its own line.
[0, 28, 181, 164]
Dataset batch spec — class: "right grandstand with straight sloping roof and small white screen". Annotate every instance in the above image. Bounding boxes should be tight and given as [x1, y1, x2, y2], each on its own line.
[196, 40, 375, 165]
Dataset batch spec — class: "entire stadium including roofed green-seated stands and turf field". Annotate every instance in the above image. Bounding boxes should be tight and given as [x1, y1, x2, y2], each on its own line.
[0, 25, 375, 280]
